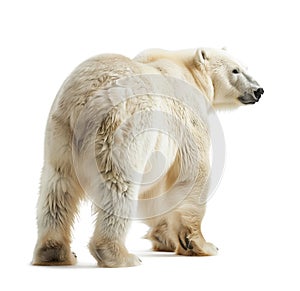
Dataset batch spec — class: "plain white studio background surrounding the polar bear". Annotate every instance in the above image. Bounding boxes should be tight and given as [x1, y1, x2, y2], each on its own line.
[0, 0, 300, 290]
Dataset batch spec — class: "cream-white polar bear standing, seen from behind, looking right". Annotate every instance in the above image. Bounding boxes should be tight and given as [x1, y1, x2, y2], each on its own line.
[32, 48, 264, 267]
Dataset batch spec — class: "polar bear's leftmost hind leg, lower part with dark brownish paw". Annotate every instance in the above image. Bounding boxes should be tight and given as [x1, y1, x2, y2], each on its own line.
[32, 165, 81, 265]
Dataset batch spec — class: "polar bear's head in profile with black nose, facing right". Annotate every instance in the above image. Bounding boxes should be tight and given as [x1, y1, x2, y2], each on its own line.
[195, 48, 264, 108]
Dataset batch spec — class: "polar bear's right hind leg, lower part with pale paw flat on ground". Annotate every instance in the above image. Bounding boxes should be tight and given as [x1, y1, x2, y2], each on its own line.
[89, 185, 141, 267]
